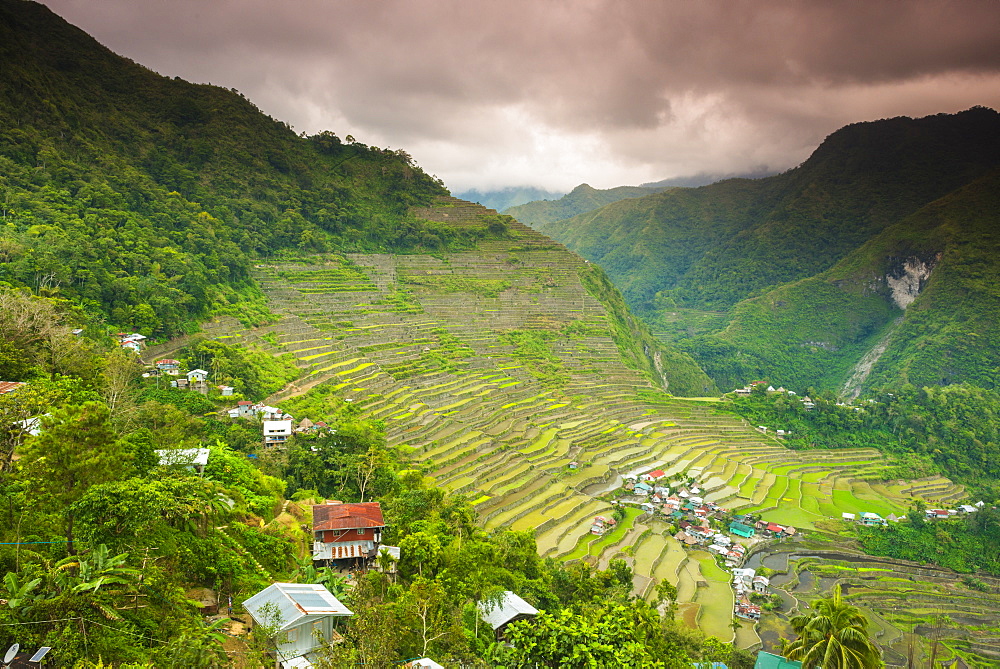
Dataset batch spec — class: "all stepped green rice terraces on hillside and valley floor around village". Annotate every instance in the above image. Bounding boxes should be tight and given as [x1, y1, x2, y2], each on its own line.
[147, 198, 1000, 664]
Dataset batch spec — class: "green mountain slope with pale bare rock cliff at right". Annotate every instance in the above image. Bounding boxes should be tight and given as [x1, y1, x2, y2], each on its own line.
[688, 171, 1000, 393]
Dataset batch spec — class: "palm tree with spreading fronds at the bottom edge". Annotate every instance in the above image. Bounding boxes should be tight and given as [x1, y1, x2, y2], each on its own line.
[782, 585, 885, 669]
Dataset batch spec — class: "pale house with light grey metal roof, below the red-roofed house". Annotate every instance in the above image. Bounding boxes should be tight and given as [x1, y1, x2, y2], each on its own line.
[243, 583, 354, 667]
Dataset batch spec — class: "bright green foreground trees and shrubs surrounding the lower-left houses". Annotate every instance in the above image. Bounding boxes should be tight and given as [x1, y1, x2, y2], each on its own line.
[0, 289, 753, 669]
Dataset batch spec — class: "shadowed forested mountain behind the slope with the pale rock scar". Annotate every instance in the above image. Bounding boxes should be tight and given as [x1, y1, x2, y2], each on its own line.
[537, 108, 1000, 314]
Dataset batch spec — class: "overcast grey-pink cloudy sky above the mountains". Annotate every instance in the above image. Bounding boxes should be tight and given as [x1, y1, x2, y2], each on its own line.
[43, 0, 1000, 191]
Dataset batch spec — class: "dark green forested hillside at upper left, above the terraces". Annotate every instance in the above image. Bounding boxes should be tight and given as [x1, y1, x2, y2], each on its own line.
[0, 0, 520, 336]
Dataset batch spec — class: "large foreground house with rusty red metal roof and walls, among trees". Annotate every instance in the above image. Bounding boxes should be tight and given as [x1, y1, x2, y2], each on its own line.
[312, 501, 385, 563]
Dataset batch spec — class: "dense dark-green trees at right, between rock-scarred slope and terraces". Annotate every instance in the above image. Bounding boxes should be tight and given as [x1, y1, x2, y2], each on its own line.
[719, 384, 1000, 500]
